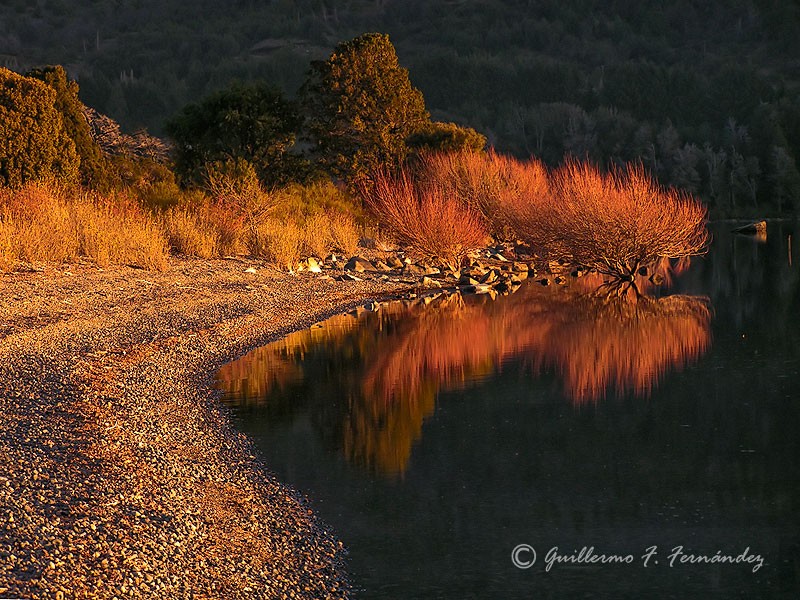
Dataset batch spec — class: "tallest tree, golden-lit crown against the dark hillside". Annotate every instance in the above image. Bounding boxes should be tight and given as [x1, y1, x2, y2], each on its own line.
[300, 33, 429, 183]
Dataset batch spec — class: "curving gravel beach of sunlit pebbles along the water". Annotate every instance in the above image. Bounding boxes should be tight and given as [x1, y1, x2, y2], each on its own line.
[0, 258, 408, 598]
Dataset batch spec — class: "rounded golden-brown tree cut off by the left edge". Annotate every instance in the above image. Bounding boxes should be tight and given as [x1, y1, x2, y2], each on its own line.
[0, 68, 80, 187]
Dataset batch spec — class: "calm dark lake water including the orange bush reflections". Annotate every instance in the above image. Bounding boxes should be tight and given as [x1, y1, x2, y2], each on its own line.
[220, 224, 800, 599]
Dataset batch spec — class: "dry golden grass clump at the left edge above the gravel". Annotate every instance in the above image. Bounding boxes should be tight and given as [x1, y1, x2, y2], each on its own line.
[0, 183, 169, 270]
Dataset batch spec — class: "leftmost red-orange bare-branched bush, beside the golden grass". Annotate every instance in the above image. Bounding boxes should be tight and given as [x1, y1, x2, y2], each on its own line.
[364, 170, 487, 267]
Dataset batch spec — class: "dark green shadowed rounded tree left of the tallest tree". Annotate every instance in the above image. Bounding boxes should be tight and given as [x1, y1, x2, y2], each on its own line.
[166, 83, 305, 186]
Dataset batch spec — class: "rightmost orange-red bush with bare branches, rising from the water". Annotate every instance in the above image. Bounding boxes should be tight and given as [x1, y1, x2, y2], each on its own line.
[510, 161, 709, 280]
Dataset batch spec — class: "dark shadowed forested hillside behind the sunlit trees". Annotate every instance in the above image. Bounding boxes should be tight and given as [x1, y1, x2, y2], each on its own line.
[0, 0, 800, 216]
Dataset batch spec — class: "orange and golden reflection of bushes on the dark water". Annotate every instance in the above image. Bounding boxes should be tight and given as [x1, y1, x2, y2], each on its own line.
[219, 283, 711, 473]
